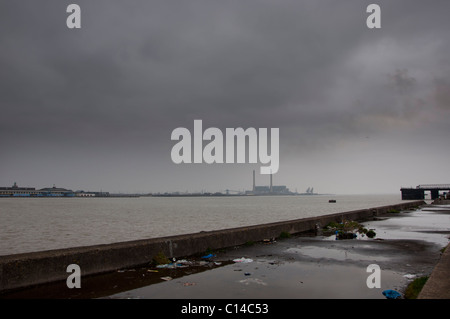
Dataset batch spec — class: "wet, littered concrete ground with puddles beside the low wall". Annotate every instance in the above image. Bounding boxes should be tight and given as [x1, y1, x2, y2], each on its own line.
[2, 206, 450, 299]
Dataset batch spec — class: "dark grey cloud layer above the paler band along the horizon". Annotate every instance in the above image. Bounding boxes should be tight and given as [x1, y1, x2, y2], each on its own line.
[0, 0, 450, 192]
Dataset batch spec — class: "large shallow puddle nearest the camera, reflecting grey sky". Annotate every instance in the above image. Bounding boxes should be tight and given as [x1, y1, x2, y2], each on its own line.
[109, 262, 407, 299]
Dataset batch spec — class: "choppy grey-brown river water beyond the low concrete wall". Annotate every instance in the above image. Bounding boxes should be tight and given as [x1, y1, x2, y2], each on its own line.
[0, 195, 408, 255]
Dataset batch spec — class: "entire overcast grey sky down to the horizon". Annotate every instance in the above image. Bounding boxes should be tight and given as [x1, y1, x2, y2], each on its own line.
[0, 0, 450, 194]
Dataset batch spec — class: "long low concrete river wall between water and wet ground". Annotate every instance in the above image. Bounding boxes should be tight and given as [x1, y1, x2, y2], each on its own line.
[0, 201, 425, 292]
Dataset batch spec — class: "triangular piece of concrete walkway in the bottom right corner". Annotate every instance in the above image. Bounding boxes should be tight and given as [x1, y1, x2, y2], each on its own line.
[418, 244, 450, 299]
